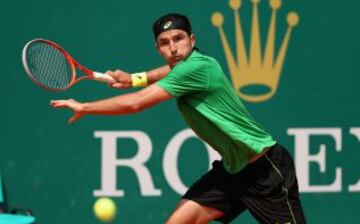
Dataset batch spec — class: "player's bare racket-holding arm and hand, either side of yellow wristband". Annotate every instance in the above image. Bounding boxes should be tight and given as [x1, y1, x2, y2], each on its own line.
[106, 65, 170, 89]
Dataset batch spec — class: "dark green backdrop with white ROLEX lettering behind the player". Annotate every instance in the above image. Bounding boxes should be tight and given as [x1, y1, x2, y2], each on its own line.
[0, 0, 360, 224]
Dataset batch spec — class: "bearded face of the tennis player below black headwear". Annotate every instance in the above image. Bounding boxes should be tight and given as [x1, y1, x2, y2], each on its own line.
[156, 29, 195, 68]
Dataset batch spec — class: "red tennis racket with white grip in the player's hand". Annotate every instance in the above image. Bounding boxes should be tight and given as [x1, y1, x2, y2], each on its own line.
[22, 39, 115, 92]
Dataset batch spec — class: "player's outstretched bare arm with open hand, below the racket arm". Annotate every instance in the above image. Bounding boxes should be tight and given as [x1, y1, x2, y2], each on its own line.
[50, 85, 172, 123]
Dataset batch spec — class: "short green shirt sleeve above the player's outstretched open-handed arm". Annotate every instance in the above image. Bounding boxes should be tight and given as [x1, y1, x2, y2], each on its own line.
[156, 59, 209, 97]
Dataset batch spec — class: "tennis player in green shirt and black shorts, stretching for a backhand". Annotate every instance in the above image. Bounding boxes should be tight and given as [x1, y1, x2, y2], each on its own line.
[51, 14, 306, 224]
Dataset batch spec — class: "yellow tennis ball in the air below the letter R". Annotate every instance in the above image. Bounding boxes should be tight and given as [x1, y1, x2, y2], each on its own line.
[94, 198, 116, 222]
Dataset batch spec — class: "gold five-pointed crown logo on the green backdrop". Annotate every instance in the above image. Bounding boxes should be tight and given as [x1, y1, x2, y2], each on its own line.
[211, 0, 299, 102]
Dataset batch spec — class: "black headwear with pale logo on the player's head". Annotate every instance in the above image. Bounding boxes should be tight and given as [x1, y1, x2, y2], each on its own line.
[152, 13, 192, 40]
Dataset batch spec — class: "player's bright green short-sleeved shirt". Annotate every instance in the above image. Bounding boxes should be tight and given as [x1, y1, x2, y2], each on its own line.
[156, 51, 275, 173]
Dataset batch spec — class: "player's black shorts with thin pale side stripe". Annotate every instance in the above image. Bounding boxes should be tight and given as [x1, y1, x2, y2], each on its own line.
[183, 144, 306, 224]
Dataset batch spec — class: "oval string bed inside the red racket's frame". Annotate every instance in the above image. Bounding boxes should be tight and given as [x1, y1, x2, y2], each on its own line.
[26, 42, 72, 90]
